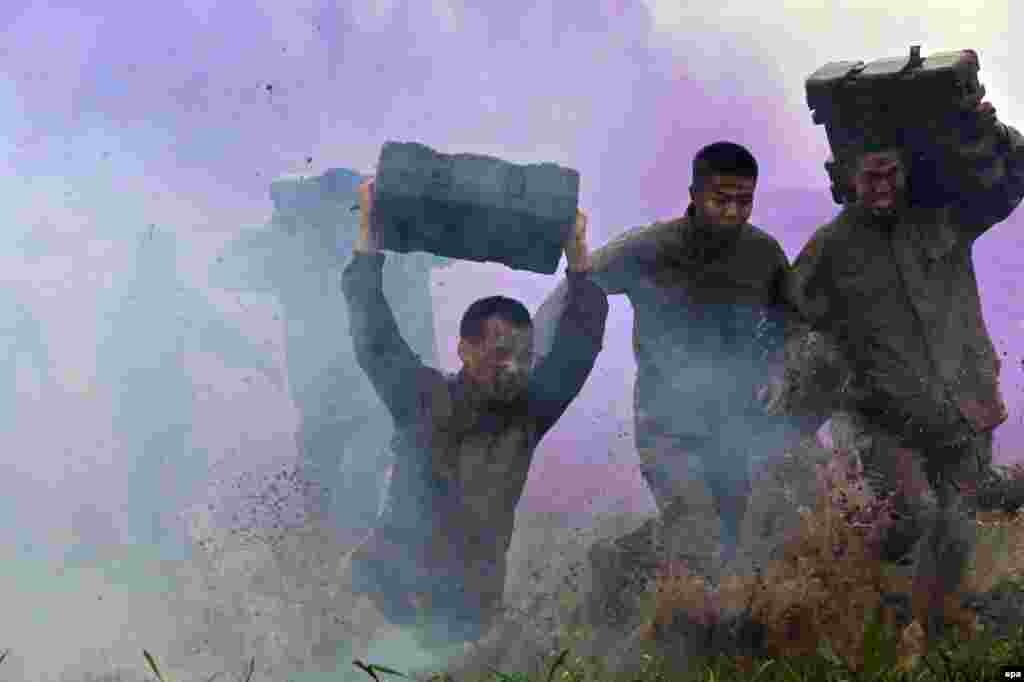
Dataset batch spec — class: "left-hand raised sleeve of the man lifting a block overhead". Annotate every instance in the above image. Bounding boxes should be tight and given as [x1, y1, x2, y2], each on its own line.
[341, 252, 426, 422]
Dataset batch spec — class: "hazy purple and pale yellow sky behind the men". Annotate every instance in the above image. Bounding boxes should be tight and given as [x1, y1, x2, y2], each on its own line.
[0, 0, 1024, 537]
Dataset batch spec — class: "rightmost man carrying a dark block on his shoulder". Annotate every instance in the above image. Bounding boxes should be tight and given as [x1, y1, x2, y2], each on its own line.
[776, 80, 1024, 636]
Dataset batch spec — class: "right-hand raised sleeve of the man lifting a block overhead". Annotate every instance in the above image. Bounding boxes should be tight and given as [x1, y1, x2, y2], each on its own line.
[529, 271, 608, 434]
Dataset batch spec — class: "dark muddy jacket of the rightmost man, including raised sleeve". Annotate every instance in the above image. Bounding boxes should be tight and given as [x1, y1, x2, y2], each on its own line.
[787, 124, 1024, 444]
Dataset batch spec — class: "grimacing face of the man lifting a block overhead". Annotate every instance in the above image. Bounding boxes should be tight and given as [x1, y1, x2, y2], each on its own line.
[459, 317, 534, 402]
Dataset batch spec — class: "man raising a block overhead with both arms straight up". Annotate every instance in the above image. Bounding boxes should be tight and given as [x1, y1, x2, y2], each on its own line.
[342, 178, 608, 645]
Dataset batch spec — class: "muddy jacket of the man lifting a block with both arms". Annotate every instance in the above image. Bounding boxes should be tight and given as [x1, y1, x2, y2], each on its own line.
[342, 253, 608, 602]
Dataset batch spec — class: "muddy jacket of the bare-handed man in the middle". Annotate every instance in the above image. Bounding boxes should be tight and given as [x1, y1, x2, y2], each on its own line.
[573, 206, 788, 439]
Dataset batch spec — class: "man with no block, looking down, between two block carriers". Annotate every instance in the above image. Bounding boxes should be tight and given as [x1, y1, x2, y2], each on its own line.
[555, 142, 788, 576]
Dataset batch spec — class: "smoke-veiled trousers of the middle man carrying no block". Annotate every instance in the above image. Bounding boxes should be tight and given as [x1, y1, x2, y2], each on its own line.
[637, 434, 751, 572]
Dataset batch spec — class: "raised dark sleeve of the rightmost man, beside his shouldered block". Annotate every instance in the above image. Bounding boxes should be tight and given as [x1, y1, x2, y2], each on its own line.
[938, 116, 1024, 233]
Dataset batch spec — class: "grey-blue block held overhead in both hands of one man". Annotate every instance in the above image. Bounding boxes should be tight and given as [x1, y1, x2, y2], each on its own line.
[374, 142, 580, 274]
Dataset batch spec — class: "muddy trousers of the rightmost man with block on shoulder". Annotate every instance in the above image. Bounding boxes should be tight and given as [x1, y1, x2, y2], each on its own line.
[831, 414, 992, 637]
